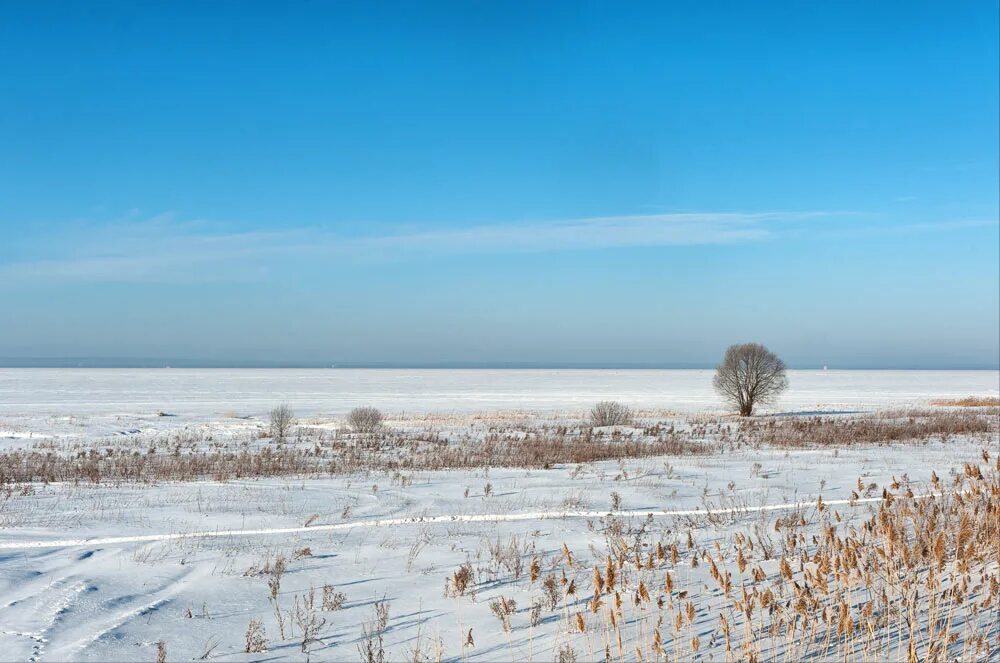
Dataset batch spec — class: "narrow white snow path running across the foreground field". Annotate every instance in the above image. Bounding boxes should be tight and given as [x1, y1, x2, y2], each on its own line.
[0, 493, 936, 550]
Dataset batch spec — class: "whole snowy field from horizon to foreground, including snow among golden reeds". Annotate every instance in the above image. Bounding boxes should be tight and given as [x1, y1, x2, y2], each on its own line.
[0, 369, 1000, 661]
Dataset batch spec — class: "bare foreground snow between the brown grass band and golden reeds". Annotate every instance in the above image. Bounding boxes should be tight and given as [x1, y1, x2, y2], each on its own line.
[0, 443, 992, 660]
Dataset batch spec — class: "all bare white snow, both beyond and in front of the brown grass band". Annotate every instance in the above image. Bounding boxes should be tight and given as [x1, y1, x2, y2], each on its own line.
[0, 369, 998, 661]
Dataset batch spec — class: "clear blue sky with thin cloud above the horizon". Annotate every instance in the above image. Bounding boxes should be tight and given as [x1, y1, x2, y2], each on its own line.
[0, 2, 1000, 367]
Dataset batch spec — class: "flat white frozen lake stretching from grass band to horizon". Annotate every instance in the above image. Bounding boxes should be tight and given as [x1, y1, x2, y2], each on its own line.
[0, 368, 1000, 417]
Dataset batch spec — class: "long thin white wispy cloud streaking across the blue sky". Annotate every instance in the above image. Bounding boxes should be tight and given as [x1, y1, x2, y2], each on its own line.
[0, 211, 968, 282]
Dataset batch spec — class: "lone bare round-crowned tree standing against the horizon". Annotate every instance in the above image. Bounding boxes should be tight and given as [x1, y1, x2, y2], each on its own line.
[712, 343, 788, 417]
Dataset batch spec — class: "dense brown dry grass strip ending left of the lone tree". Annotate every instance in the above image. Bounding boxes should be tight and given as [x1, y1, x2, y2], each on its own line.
[0, 431, 708, 487]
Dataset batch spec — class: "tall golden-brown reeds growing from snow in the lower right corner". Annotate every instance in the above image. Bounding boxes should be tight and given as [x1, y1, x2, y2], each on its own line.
[460, 451, 1000, 663]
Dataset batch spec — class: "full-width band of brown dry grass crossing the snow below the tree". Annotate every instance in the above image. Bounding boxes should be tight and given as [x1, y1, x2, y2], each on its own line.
[0, 409, 1000, 491]
